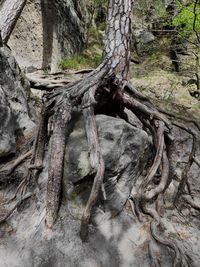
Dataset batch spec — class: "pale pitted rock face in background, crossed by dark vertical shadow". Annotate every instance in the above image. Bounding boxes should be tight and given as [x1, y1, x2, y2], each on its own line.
[9, 0, 87, 71]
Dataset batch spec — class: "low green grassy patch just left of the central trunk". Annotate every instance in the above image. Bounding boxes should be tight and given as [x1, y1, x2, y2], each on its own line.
[59, 54, 101, 70]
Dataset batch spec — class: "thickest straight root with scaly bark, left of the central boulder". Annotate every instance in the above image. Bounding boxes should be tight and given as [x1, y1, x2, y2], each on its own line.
[46, 102, 72, 228]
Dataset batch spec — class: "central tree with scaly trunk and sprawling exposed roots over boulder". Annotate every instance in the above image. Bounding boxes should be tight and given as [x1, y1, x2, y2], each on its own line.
[0, 0, 200, 267]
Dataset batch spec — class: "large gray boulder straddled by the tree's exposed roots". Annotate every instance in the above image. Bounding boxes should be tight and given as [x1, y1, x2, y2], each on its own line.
[64, 115, 151, 214]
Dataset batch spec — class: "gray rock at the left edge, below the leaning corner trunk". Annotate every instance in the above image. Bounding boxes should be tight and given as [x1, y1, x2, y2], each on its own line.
[0, 47, 35, 157]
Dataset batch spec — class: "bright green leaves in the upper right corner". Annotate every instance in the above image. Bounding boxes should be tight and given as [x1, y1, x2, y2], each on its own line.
[172, 1, 200, 36]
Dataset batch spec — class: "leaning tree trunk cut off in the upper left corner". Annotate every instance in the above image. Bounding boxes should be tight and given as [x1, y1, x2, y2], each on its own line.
[0, 0, 26, 43]
